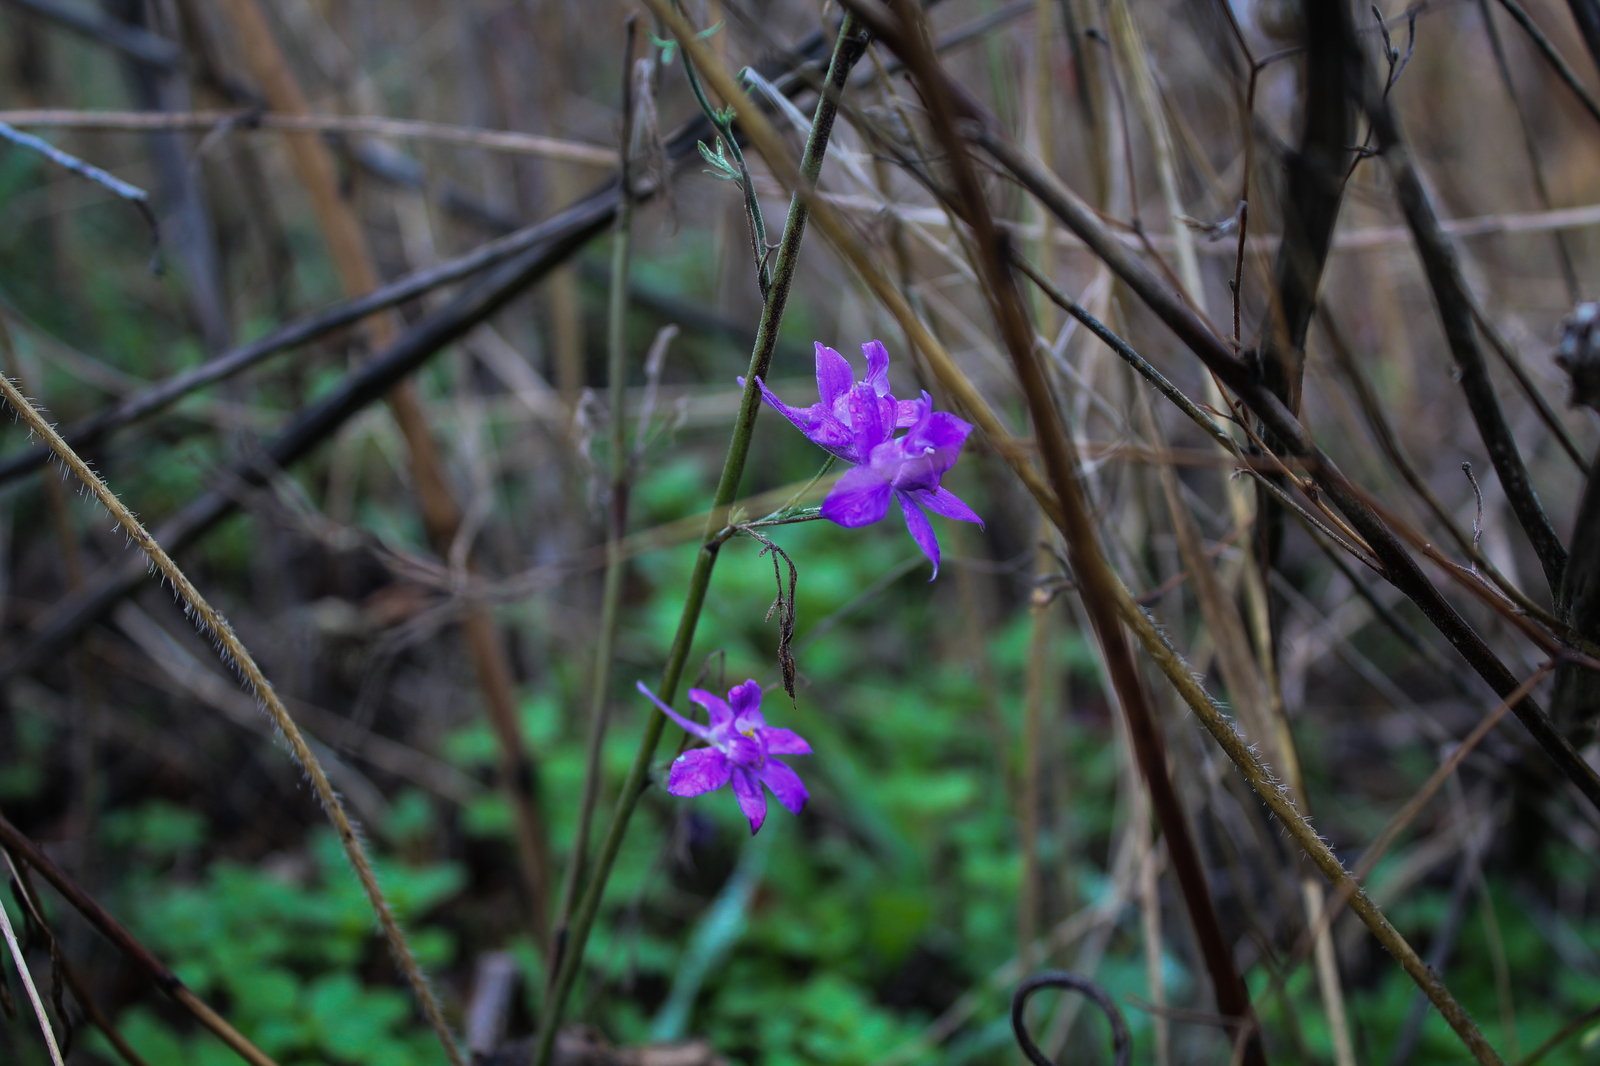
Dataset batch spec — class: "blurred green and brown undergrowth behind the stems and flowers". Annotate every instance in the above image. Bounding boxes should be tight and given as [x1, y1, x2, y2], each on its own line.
[0, 0, 1600, 1066]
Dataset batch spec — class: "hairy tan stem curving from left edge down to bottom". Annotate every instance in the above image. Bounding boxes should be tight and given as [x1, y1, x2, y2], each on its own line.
[0, 375, 464, 1066]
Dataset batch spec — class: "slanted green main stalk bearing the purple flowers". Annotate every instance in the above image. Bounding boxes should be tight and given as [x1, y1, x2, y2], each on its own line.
[533, 12, 867, 1066]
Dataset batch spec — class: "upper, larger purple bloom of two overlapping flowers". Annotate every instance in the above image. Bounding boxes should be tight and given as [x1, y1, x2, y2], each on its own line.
[755, 341, 984, 579]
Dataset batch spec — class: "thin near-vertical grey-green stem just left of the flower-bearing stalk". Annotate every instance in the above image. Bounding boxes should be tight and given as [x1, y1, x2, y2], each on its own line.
[546, 16, 650, 992]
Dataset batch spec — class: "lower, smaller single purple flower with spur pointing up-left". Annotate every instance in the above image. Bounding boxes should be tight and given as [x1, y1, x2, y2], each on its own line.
[638, 680, 811, 836]
